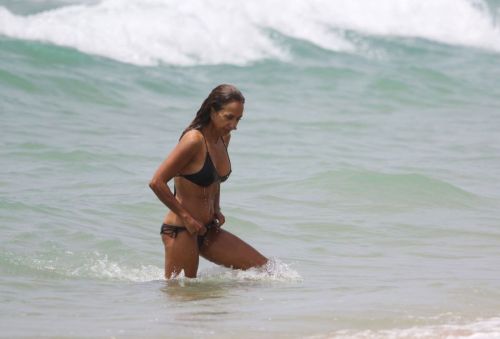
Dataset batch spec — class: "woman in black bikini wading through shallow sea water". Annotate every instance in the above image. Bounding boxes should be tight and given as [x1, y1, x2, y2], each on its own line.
[149, 85, 267, 279]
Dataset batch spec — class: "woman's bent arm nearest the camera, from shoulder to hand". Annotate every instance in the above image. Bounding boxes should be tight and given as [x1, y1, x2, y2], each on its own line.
[149, 132, 205, 233]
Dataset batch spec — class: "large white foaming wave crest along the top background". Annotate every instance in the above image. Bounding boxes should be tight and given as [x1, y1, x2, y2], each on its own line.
[0, 0, 500, 65]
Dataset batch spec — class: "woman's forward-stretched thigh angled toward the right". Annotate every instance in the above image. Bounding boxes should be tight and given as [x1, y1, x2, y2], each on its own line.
[200, 228, 267, 270]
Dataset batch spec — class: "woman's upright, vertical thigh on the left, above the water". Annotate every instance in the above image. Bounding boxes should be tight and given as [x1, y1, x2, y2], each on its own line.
[161, 231, 199, 279]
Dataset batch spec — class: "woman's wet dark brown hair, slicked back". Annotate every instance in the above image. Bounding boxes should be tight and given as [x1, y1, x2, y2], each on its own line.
[181, 84, 245, 138]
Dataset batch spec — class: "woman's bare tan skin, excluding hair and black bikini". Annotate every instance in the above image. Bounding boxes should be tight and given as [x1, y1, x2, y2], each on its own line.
[149, 101, 267, 279]
